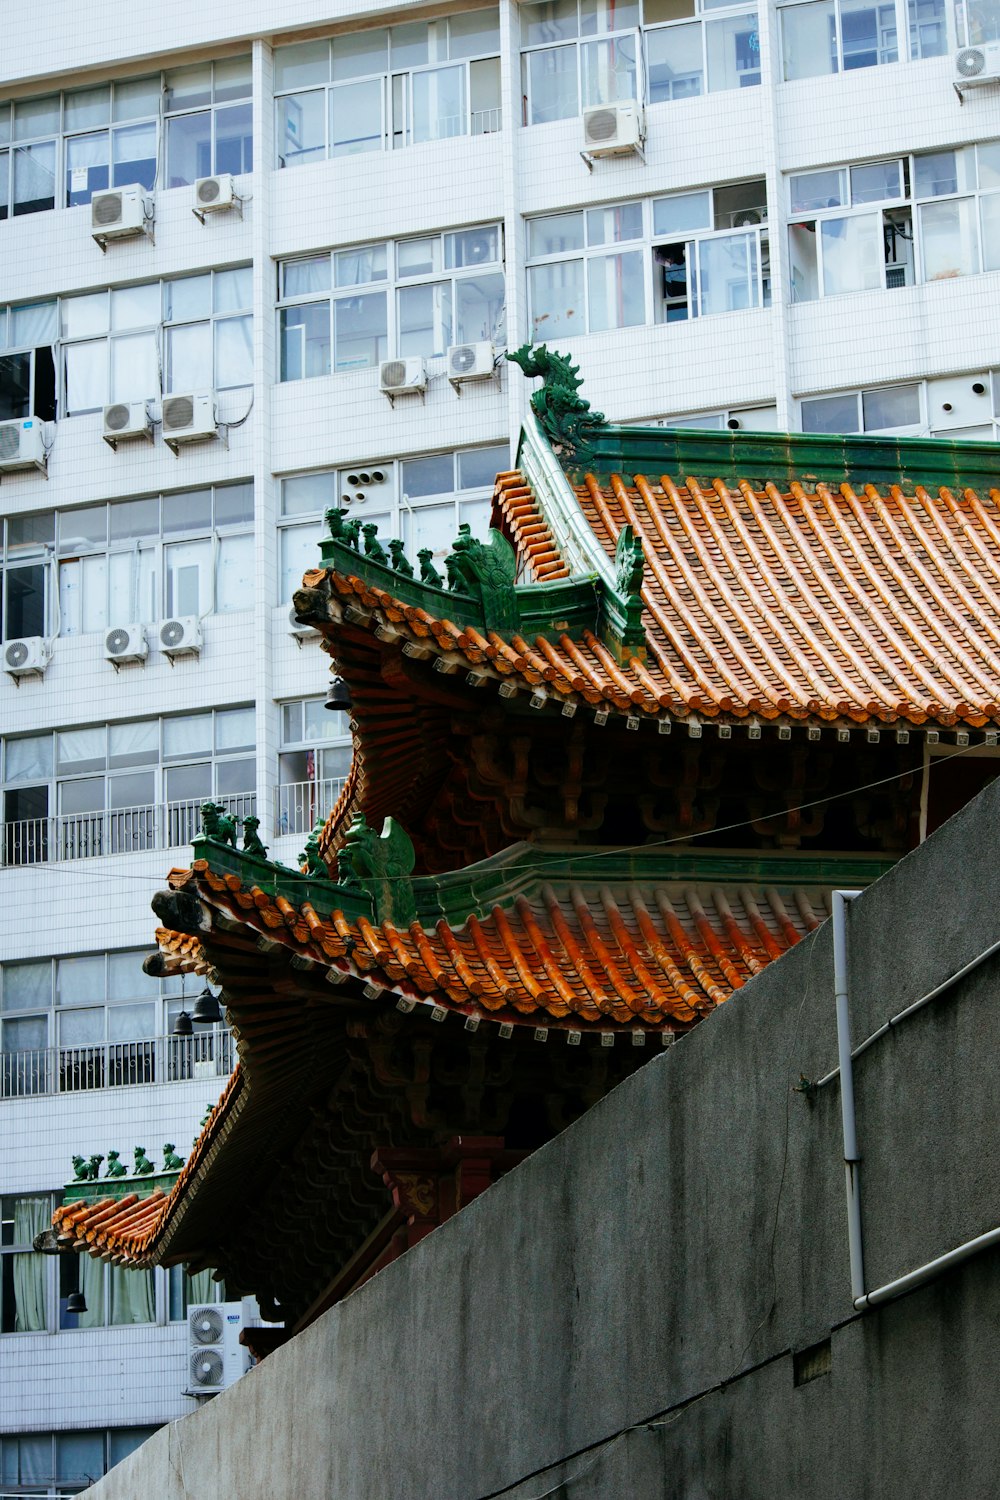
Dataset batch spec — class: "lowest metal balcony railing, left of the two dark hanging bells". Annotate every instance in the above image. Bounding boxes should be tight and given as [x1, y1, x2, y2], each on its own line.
[0, 1031, 235, 1100]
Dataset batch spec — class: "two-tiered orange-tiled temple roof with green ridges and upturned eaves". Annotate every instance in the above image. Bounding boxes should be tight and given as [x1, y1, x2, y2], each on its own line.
[54, 350, 1000, 1326]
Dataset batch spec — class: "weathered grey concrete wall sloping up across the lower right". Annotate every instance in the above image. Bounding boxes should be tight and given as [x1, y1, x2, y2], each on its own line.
[87, 783, 1000, 1500]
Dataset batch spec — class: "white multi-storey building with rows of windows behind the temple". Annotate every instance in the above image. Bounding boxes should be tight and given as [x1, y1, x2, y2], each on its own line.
[0, 0, 1000, 1494]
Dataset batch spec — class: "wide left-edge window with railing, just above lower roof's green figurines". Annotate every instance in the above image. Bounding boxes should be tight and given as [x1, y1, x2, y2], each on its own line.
[3, 708, 256, 864]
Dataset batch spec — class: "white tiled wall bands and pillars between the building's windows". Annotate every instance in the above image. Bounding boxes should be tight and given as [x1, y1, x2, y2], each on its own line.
[0, 0, 1000, 1488]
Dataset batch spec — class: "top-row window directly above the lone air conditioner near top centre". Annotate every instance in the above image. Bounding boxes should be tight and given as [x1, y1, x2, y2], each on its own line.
[520, 0, 760, 125]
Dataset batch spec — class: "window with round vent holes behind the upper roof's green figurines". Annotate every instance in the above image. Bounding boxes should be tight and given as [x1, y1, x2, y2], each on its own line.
[279, 443, 510, 597]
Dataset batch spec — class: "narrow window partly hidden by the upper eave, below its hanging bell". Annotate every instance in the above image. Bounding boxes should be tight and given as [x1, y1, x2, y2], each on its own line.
[274, 698, 352, 834]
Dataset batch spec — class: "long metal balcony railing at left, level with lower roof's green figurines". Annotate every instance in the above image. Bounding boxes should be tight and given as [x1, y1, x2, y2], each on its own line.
[0, 792, 256, 866]
